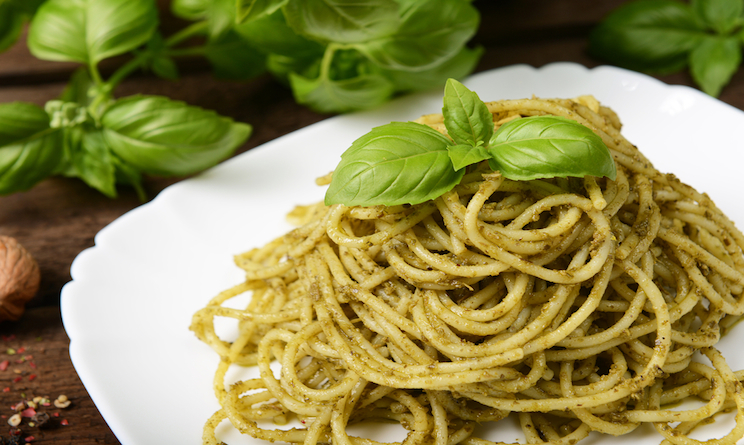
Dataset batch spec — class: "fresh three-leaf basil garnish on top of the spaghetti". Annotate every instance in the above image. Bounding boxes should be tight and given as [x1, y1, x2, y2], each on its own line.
[325, 79, 616, 206]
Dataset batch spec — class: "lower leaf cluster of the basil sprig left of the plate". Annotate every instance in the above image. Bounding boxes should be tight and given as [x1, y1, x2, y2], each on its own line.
[0, 93, 251, 200]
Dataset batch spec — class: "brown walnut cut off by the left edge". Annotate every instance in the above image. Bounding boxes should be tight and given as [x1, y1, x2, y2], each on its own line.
[0, 235, 41, 321]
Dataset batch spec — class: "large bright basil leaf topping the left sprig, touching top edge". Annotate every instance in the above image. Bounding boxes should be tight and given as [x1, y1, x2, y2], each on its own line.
[28, 0, 158, 64]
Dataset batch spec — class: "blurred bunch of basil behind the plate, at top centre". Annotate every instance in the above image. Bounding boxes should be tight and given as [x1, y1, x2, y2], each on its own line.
[171, 0, 482, 113]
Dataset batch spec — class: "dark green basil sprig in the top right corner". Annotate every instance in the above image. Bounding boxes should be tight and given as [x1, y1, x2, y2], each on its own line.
[589, 0, 744, 96]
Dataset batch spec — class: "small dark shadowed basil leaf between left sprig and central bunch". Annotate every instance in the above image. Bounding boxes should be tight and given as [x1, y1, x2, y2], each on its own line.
[204, 30, 266, 80]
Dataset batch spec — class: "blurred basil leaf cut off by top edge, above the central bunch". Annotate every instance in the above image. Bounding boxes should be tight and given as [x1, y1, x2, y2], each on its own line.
[284, 0, 399, 43]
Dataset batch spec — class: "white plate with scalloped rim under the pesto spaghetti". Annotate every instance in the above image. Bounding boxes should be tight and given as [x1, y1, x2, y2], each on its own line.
[61, 63, 744, 445]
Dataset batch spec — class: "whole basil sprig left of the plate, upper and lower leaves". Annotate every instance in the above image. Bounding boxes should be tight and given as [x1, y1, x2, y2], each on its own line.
[0, 0, 251, 199]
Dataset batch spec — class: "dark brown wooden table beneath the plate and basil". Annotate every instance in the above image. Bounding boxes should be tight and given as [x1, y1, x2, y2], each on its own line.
[0, 0, 744, 445]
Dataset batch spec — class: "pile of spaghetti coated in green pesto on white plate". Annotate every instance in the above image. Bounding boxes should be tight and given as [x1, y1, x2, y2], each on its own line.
[191, 97, 744, 445]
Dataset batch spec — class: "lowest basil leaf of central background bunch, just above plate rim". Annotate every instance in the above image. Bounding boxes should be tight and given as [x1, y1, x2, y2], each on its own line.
[289, 58, 394, 113]
